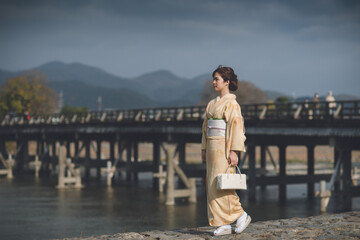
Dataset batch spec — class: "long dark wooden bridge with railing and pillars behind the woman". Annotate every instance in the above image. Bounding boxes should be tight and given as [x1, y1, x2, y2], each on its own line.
[0, 100, 360, 209]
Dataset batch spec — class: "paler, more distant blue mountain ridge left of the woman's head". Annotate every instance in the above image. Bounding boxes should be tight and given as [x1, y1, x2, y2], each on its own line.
[35, 61, 210, 105]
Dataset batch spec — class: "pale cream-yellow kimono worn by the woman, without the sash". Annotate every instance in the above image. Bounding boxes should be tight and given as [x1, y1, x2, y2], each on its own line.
[201, 93, 246, 226]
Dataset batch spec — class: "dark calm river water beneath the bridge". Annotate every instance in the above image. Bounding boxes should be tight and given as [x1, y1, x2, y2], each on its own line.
[0, 173, 360, 239]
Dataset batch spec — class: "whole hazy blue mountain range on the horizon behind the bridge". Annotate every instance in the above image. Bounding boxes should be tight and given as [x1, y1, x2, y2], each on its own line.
[0, 61, 360, 109]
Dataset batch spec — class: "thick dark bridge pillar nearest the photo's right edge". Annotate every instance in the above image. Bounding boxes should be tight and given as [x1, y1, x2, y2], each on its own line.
[341, 150, 352, 211]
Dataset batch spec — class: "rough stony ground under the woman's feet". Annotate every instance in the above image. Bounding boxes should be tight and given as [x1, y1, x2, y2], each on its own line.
[60, 211, 360, 240]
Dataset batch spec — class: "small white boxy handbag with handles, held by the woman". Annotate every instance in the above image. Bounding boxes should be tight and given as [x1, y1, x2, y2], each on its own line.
[216, 165, 246, 189]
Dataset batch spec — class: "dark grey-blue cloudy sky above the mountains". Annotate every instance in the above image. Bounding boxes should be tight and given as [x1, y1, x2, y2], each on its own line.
[0, 0, 360, 96]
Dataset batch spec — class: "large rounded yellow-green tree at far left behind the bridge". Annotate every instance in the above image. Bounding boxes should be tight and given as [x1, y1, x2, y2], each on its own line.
[0, 71, 57, 115]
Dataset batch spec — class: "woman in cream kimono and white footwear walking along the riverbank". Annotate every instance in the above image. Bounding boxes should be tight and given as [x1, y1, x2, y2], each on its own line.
[201, 66, 251, 236]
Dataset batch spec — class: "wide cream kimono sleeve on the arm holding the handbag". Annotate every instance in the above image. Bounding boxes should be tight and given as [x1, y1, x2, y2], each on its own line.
[224, 102, 246, 158]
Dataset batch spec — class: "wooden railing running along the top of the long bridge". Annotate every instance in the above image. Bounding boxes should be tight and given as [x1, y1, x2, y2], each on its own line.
[1, 100, 360, 126]
